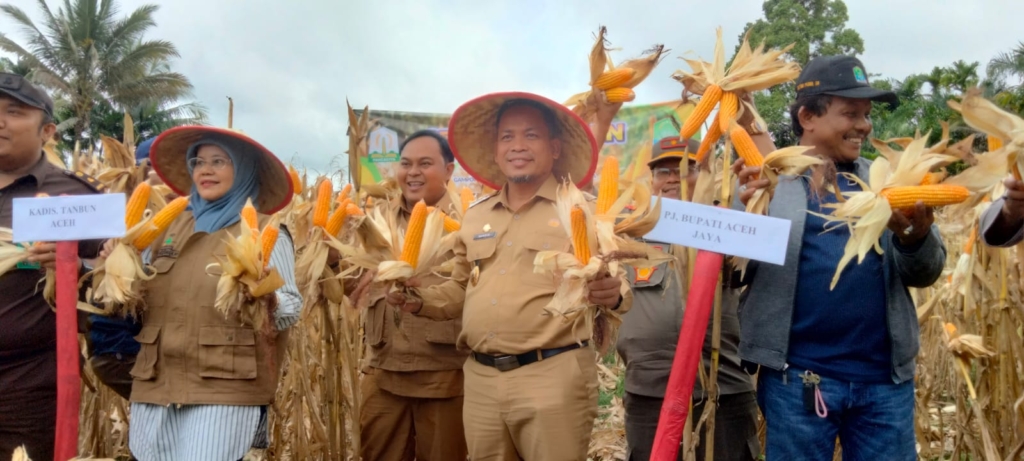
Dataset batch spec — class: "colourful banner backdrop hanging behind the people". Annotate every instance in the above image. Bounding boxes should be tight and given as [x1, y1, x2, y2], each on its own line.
[356, 100, 699, 196]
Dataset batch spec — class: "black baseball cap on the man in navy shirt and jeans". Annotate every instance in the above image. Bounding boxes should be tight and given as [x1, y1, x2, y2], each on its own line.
[797, 56, 899, 109]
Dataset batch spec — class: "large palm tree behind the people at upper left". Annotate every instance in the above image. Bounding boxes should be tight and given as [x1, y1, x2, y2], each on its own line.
[0, 0, 191, 145]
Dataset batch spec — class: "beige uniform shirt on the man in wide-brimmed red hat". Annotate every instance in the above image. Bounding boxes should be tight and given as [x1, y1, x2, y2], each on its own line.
[420, 177, 633, 355]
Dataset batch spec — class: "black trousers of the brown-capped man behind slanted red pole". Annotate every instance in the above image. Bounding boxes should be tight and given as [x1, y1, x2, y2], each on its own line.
[624, 392, 761, 461]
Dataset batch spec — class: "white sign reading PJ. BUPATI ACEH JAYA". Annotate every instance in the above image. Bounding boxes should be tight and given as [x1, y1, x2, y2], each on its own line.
[644, 199, 793, 265]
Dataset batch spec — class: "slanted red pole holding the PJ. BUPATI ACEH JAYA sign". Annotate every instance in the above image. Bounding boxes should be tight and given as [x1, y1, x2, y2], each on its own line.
[650, 250, 724, 461]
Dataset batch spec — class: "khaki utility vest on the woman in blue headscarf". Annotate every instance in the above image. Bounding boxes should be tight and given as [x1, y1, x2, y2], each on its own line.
[131, 211, 288, 405]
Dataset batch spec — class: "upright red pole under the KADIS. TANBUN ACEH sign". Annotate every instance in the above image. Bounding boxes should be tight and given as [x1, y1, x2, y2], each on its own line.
[53, 242, 82, 461]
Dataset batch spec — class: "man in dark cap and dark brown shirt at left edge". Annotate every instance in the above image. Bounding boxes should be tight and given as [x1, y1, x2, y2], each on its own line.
[0, 74, 102, 460]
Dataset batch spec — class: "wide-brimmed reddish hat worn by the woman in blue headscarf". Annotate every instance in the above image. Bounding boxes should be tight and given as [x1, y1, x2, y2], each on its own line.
[150, 126, 292, 214]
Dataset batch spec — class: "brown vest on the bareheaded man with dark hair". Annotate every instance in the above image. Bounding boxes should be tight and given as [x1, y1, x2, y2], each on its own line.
[366, 196, 469, 372]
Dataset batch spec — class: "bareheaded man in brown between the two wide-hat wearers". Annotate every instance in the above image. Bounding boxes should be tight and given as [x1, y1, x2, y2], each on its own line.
[359, 130, 468, 461]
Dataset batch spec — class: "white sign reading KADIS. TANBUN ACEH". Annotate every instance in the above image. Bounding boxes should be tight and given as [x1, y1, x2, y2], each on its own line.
[12, 194, 125, 243]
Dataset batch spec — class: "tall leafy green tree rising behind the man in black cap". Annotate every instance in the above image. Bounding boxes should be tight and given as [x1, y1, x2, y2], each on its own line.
[736, 0, 864, 148]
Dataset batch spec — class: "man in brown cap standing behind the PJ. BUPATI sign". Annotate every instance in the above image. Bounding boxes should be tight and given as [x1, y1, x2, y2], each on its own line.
[616, 137, 761, 461]
